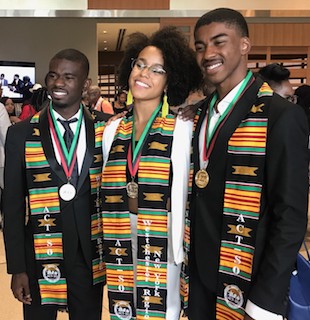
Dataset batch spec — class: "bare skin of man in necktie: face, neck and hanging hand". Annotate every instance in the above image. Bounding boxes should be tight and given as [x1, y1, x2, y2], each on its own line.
[11, 59, 90, 305]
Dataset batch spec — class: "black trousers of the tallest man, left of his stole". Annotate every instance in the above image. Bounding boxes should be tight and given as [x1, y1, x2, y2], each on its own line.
[188, 257, 216, 320]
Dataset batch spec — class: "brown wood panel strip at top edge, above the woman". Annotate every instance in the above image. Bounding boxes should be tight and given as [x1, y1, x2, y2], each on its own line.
[88, 0, 170, 10]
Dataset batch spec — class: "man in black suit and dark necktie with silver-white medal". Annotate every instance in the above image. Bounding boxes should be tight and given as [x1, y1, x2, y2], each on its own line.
[4, 49, 105, 320]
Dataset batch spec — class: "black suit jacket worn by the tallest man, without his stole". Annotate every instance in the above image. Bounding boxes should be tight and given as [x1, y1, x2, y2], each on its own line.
[191, 80, 309, 314]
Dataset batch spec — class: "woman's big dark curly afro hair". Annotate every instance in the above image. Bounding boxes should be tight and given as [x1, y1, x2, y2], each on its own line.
[119, 26, 202, 106]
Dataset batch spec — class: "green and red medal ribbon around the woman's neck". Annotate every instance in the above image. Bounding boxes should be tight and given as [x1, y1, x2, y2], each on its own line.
[127, 102, 162, 178]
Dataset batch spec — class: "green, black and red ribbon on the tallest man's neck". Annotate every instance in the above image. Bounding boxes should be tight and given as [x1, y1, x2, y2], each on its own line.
[203, 71, 254, 162]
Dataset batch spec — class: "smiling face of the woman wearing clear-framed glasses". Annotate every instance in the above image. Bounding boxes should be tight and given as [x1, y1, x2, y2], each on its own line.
[129, 46, 167, 105]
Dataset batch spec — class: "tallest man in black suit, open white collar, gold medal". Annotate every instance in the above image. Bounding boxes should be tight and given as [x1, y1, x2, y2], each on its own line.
[188, 8, 308, 320]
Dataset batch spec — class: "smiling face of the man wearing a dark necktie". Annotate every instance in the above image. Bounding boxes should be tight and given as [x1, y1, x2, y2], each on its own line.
[46, 59, 88, 114]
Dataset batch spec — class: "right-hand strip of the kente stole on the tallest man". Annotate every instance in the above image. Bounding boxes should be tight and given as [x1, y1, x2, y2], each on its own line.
[216, 83, 273, 320]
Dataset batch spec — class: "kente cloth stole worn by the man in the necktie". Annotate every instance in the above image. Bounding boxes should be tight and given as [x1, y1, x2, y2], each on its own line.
[25, 114, 105, 305]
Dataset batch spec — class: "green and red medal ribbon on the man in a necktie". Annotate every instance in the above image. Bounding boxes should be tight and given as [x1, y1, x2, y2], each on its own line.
[48, 103, 83, 180]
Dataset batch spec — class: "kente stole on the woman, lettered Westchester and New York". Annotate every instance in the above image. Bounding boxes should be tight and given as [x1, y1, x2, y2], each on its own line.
[102, 114, 177, 320]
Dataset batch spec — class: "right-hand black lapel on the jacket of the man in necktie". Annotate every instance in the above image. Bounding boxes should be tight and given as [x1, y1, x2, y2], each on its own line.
[77, 107, 95, 191]
